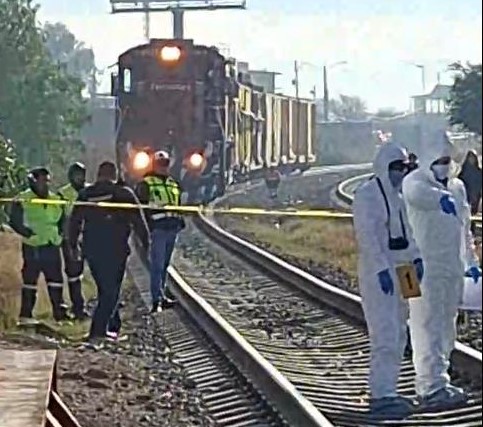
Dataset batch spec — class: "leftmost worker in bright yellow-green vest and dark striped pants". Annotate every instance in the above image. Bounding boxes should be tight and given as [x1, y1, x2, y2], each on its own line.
[10, 168, 68, 323]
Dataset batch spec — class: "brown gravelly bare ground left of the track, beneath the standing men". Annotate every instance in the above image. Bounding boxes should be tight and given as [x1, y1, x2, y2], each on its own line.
[0, 233, 212, 427]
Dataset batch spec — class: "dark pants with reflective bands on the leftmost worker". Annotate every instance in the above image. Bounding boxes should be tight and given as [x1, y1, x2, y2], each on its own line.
[20, 245, 65, 320]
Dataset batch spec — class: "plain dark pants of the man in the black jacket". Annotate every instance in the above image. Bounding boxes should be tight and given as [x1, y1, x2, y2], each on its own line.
[86, 251, 127, 338]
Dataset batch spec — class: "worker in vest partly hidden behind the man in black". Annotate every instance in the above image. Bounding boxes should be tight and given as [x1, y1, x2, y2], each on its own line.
[58, 162, 88, 320]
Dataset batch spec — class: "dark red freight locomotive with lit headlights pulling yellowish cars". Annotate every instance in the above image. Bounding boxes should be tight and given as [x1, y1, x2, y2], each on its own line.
[111, 39, 316, 201]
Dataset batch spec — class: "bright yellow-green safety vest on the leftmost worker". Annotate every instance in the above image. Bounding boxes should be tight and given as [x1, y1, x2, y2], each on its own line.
[19, 190, 64, 247]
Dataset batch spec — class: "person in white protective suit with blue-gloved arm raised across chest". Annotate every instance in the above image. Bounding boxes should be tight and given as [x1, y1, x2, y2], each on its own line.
[403, 132, 481, 410]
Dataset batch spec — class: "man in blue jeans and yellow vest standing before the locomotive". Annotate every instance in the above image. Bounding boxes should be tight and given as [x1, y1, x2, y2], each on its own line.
[136, 151, 185, 313]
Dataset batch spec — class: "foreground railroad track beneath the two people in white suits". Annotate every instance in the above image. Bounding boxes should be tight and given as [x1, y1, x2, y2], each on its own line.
[124, 169, 482, 427]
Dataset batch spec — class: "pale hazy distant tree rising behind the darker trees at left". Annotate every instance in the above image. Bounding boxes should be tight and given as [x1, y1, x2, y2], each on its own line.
[43, 22, 96, 84]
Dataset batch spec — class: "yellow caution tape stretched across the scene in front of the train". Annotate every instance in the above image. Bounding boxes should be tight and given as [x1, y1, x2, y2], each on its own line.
[0, 198, 481, 222]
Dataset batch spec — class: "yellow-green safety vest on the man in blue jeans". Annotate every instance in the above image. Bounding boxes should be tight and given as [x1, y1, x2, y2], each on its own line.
[144, 176, 181, 221]
